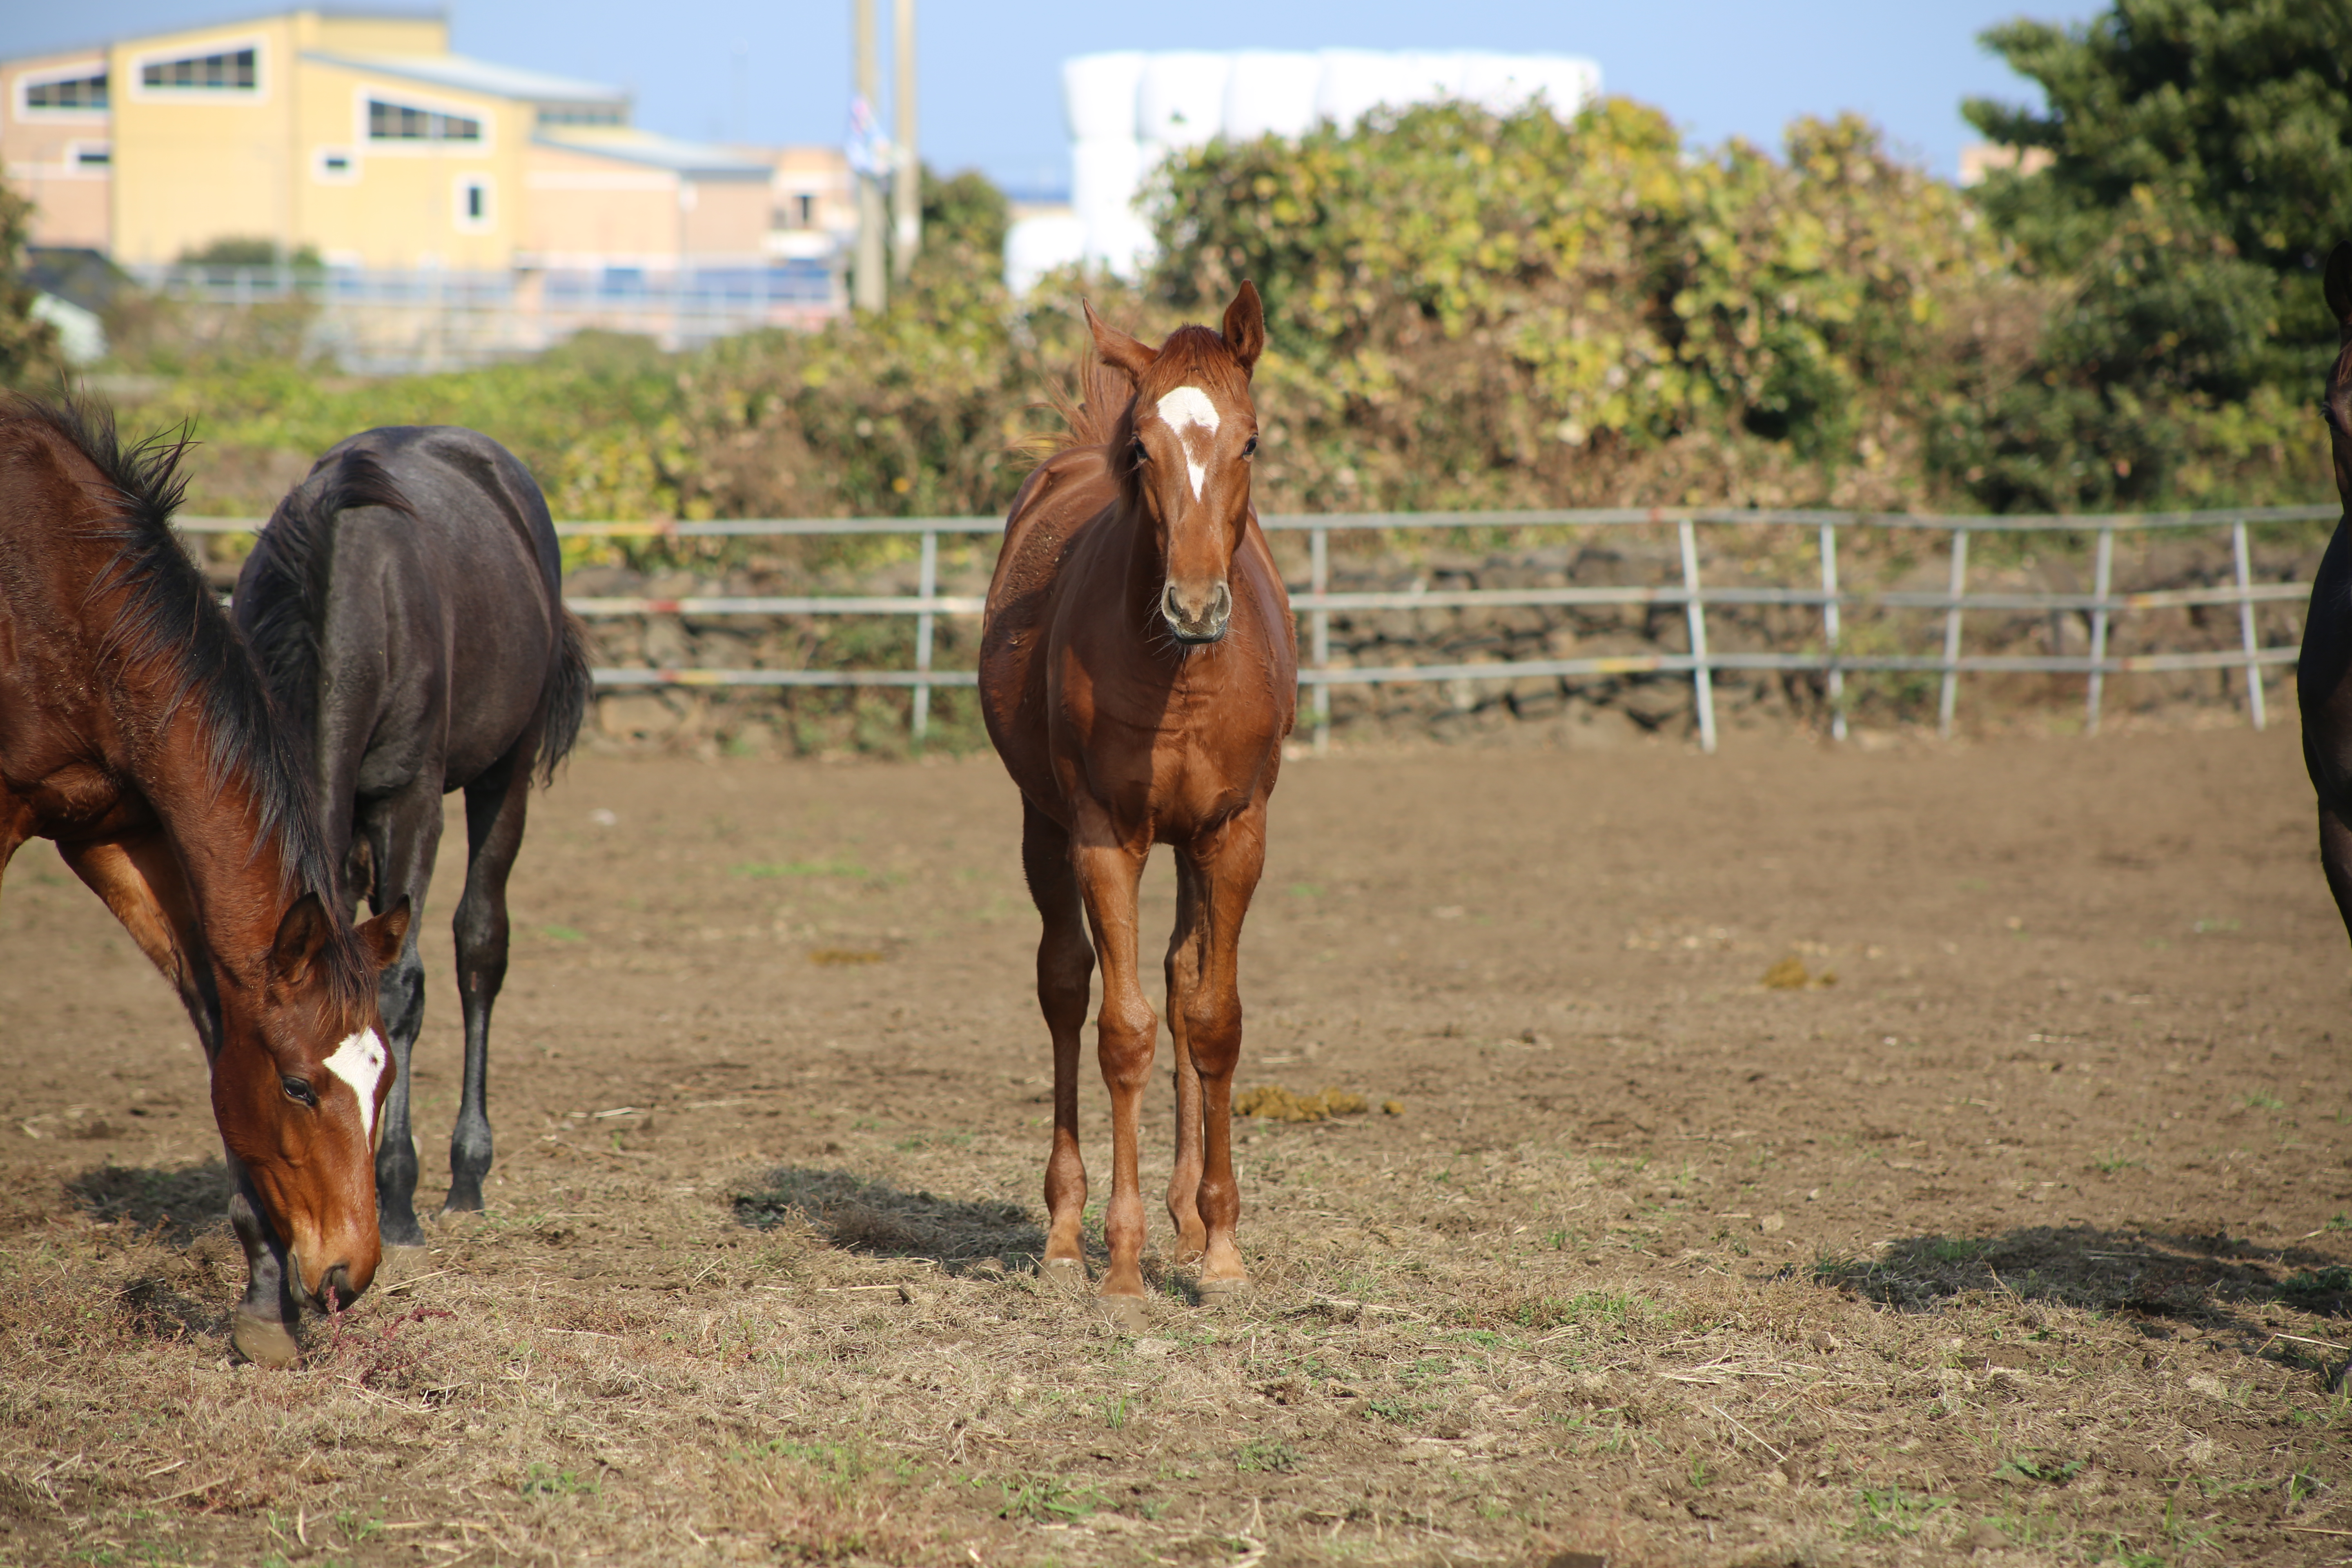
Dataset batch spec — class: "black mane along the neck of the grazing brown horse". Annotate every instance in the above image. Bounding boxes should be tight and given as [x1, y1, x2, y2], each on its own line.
[0, 392, 365, 982]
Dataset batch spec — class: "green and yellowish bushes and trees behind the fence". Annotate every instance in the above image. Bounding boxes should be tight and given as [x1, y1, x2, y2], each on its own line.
[0, 0, 2352, 531]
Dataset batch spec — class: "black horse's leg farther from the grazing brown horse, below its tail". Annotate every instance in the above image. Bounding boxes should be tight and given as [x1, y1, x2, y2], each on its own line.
[442, 747, 539, 1211]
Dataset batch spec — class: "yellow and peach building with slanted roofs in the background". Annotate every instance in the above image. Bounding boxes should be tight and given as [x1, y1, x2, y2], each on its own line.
[0, 9, 847, 273]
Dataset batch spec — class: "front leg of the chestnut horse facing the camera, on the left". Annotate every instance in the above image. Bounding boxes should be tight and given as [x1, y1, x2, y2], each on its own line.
[1070, 816, 1160, 1333]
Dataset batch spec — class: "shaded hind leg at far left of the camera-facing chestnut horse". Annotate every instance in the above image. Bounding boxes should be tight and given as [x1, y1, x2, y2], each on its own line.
[1021, 799, 1094, 1279]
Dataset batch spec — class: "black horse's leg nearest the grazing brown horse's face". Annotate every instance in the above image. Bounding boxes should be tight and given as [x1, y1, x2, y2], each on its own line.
[360, 778, 442, 1246]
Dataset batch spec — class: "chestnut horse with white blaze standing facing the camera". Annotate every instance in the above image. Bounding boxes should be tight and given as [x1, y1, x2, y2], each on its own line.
[981, 282, 1298, 1333]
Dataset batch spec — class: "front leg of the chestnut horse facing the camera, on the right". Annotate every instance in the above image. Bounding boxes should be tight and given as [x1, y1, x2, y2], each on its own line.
[1169, 799, 1265, 1298]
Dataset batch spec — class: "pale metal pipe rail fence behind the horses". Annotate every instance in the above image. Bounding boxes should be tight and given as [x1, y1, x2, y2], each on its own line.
[179, 506, 2340, 752]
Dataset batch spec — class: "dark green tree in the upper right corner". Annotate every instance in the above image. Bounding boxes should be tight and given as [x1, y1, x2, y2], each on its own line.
[1964, 0, 2352, 506]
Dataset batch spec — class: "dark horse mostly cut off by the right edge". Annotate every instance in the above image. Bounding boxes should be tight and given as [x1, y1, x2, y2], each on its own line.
[2296, 242, 2352, 959]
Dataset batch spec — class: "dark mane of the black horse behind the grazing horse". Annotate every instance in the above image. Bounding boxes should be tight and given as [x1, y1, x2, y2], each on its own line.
[245, 451, 416, 745]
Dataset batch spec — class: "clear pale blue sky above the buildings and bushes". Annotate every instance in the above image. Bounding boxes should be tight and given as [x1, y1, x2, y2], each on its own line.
[0, 0, 2103, 188]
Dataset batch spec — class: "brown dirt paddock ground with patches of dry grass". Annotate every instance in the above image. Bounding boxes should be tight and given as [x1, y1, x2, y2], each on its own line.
[0, 710, 2352, 1568]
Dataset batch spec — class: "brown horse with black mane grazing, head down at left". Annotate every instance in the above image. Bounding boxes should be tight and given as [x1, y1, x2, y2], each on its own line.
[0, 397, 409, 1363]
